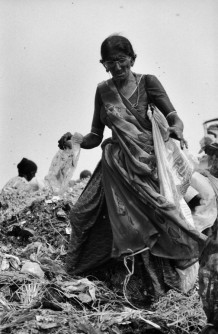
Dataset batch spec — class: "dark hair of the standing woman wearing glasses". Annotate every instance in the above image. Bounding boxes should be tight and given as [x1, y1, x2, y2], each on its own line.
[100, 35, 136, 62]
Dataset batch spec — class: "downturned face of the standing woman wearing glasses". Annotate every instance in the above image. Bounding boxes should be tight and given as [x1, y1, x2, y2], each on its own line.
[103, 50, 132, 80]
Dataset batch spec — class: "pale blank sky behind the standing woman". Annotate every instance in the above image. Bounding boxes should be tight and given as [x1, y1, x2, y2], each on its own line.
[0, 0, 218, 188]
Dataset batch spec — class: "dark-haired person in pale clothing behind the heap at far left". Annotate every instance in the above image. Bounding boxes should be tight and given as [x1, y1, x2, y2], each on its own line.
[2, 158, 38, 191]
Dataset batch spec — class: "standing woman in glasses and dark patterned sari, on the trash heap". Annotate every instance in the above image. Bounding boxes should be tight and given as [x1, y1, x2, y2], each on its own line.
[59, 35, 211, 304]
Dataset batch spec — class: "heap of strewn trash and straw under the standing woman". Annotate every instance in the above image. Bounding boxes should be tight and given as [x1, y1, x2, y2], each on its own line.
[0, 180, 206, 334]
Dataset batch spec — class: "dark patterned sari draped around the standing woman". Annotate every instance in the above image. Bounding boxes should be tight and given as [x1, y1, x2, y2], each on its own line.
[67, 75, 206, 295]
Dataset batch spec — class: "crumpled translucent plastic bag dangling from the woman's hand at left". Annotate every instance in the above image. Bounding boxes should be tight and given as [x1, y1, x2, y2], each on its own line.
[45, 137, 80, 194]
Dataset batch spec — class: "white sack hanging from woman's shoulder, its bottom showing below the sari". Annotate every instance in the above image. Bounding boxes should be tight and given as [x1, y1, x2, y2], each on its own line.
[148, 109, 199, 293]
